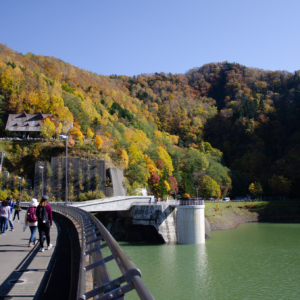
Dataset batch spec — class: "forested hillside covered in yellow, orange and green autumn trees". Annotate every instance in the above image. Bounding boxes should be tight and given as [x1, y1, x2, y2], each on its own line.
[0, 44, 300, 197]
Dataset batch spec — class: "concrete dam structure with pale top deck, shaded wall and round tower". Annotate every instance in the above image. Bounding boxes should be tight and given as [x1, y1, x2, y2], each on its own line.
[73, 196, 209, 244]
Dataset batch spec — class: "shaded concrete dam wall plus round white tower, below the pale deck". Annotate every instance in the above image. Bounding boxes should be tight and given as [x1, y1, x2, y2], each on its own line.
[100, 204, 205, 244]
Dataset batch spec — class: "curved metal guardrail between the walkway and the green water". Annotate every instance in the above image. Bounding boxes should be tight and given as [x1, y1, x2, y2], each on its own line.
[21, 203, 154, 300]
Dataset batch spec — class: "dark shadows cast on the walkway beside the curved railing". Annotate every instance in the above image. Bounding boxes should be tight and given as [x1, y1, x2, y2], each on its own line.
[0, 213, 80, 300]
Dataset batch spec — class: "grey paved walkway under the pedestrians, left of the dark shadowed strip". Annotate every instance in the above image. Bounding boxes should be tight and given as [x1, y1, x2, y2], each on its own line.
[0, 210, 58, 300]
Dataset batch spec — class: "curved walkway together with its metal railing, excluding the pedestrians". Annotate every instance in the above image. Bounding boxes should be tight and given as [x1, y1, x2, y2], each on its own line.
[0, 203, 154, 300]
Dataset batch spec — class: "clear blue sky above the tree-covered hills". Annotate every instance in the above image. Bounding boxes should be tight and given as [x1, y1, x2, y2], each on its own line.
[0, 0, 300, 76]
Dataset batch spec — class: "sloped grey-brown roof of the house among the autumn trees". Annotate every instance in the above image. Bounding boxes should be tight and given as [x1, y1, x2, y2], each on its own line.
[5, 112, 52, 132]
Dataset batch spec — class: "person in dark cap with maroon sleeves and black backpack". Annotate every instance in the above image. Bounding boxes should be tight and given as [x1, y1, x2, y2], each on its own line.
[36, 195, 52, 252]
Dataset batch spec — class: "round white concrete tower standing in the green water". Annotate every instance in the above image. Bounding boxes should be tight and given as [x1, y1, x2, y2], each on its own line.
[177, 205, 205, 244]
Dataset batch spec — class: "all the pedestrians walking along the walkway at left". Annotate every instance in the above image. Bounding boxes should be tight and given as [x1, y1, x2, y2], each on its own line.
[0, 195, 52, 252]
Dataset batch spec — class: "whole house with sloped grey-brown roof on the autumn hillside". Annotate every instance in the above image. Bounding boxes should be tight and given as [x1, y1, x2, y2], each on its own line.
[5, 112, 52, 138]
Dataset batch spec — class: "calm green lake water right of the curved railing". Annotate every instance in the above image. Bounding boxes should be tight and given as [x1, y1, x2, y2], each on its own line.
[107, 223, 300, 300]
